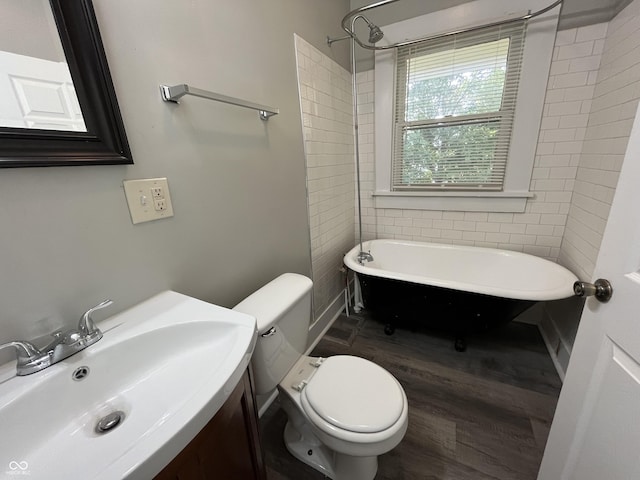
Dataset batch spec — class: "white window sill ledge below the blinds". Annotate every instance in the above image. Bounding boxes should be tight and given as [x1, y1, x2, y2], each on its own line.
[372, 191, 534, 213]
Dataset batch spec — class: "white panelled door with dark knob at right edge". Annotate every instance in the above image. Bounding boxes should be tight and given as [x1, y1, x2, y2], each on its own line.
[538, 103, 640, 480]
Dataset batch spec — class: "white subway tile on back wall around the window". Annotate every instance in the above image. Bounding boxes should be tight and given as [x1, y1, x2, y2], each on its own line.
[356, 24, 607, 261]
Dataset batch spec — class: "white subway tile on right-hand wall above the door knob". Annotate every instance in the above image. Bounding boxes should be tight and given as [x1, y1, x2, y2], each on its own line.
[555, 0, 640, 280]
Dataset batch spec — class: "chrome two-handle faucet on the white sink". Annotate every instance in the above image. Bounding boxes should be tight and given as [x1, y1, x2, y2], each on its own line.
[0, 300, 113, 376]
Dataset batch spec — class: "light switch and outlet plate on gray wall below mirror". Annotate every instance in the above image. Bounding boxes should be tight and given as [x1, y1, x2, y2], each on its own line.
[122, 178, 173, 224]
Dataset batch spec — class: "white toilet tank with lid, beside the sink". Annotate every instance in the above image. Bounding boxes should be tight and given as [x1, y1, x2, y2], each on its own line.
[233, 273, 313, 395]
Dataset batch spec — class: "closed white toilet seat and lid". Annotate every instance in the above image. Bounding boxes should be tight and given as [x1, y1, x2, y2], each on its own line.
[301, 355, 406, 434]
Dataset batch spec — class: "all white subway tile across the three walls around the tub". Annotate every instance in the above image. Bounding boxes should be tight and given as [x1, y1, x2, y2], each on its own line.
[296, 5, 640, 330]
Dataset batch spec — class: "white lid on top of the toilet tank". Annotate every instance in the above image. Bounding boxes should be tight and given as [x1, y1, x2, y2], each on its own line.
[233, 273, 313, 333]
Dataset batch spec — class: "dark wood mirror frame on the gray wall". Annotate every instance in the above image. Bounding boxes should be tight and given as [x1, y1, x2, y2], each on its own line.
[0, 0, 133, 168]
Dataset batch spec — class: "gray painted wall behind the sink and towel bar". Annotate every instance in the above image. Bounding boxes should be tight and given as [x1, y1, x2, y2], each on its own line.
[0, 0, 349, 361]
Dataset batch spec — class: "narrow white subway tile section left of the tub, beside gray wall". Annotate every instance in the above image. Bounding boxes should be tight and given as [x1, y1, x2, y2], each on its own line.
[295, 36, 355, 319]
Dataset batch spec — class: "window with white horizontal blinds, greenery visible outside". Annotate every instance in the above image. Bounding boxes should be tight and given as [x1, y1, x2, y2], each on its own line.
[392, 22, 525, 190]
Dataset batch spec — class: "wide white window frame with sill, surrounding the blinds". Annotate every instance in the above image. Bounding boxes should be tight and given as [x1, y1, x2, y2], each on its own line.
[373, 0, 559, 212]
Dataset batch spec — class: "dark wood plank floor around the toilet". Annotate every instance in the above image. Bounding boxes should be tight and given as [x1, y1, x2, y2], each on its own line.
[260, 315, 561, 480]
